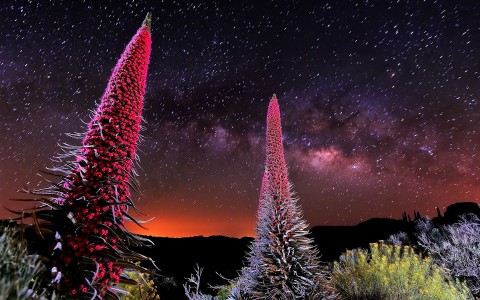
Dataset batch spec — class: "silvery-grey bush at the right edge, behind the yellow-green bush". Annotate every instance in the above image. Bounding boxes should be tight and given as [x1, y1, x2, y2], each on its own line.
[417, 214, 480, 297]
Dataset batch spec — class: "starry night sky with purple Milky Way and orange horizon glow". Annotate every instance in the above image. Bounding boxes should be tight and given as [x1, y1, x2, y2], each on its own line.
[0, 0, 480, 237]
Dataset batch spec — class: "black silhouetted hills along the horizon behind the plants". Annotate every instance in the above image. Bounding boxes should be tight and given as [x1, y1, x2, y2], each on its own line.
[0, 202, 480, 300]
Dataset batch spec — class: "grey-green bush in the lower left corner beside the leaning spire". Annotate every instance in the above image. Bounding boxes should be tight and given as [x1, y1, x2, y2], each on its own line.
[0, 224, 45, 300]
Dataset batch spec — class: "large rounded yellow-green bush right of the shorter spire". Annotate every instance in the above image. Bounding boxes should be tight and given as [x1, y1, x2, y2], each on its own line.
[332, 243, 473, 300]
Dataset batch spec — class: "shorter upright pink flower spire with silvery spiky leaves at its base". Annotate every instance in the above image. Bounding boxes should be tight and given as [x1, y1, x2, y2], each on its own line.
[234, 95, 321, 299]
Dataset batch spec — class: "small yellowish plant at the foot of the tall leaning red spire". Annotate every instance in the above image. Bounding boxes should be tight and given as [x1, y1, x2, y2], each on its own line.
[119, 269, 160, 300]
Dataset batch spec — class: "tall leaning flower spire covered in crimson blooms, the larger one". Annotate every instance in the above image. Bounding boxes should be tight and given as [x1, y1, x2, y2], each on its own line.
[11, 14, 151, 299]
